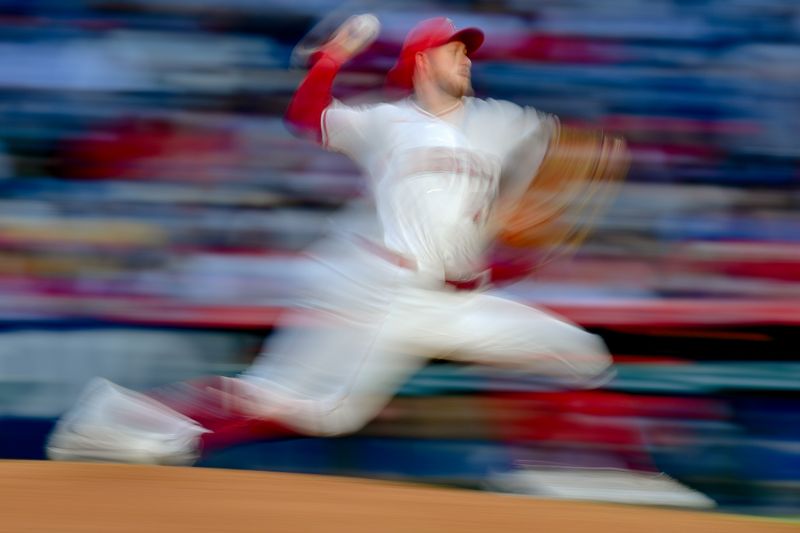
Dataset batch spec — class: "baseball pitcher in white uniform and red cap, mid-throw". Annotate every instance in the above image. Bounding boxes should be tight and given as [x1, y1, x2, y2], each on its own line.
[48, 15, 625, 463]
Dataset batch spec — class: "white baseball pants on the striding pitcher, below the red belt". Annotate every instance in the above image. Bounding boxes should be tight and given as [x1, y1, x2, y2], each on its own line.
[241, 233, 611, 435]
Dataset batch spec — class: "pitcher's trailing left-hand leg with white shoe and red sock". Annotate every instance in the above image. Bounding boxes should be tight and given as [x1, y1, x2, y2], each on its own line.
[47, 318, 425, 464]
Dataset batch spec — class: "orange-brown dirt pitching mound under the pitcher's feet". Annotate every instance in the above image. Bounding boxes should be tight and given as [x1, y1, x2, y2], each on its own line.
[0, 461, 798, 533]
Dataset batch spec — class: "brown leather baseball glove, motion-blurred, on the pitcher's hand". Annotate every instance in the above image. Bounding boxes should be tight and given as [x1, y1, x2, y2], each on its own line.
[495, 117, 630, 260]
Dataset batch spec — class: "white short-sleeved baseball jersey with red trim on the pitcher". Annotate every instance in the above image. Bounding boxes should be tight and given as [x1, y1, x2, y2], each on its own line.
[322, 97, 542, 279]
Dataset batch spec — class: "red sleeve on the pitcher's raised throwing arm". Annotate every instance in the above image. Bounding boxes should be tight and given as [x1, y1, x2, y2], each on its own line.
[284, 53, 342, 144]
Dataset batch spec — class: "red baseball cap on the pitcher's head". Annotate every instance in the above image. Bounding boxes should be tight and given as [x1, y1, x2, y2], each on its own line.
[386, 17, 483, 89]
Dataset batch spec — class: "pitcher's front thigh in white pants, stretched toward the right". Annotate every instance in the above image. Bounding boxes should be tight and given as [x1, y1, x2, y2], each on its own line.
[448, 294, 611, 378]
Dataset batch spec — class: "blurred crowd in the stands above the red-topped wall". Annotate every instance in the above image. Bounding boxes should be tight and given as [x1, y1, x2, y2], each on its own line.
[0, 1, 800, 322]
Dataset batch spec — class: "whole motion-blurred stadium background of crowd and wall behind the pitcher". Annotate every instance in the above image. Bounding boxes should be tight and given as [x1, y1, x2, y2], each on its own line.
[0, 0, 800, 515]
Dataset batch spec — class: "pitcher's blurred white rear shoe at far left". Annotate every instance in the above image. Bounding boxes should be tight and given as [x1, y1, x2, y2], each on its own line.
[46, 378, 208, 465]
